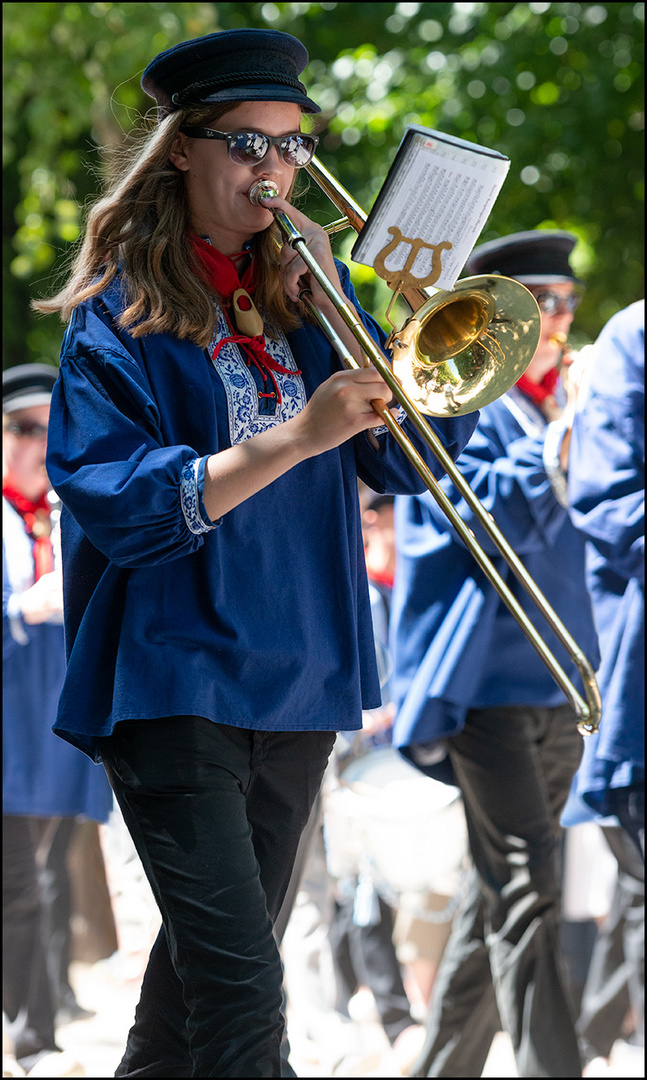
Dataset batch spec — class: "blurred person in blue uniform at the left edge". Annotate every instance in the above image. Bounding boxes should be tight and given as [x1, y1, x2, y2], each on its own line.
[2, 364, 112, 1076]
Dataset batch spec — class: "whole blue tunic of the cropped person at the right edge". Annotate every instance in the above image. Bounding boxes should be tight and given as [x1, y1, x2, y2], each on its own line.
[564, 301, 645, 824]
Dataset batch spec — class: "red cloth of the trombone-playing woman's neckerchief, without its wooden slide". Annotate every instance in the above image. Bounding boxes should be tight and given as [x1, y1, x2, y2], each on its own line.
[189, 233, 301, 405]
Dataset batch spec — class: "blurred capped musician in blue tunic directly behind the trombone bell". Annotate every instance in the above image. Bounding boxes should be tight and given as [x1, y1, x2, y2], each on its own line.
[391, 230, 596, 1077]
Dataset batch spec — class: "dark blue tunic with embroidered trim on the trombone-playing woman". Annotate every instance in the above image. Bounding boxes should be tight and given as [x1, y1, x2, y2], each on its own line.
[48, 267, 475, 755]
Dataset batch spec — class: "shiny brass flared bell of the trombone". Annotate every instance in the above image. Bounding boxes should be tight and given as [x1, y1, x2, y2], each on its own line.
[390, 274, 541, 417]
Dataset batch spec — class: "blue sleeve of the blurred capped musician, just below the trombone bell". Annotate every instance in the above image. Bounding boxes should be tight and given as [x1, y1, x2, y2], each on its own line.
[426, 401, 567, 556]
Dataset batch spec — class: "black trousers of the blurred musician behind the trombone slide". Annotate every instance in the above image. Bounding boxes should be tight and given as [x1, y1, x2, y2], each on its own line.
[412, 705, 582, 1077]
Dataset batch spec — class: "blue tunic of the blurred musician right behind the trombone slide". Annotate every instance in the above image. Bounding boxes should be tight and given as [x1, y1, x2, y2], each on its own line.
[391, 380, 597, 780]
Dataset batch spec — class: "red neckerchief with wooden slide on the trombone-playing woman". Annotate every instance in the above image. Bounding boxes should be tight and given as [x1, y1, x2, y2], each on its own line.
[189, 233, 301, 405]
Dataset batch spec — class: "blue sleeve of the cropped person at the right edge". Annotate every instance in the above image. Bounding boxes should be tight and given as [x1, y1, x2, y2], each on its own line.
[568, 302, 645, 582]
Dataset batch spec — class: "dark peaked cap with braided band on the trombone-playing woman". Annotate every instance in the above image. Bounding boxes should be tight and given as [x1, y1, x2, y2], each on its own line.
[141, 30, 321, 112]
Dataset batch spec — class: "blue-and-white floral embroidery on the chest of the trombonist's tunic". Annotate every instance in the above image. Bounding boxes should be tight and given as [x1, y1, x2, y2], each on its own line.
[210, 310, 307, 446]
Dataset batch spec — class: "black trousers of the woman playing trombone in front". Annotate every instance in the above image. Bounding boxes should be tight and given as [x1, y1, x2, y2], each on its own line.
[102, 716, 335, 1077]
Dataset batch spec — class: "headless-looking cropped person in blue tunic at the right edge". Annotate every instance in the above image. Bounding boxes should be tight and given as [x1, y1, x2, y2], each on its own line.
[563, 301, 645, 1076]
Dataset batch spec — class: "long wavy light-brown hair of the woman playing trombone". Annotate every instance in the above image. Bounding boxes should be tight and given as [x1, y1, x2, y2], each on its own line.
[31, 103, 302, 348]
